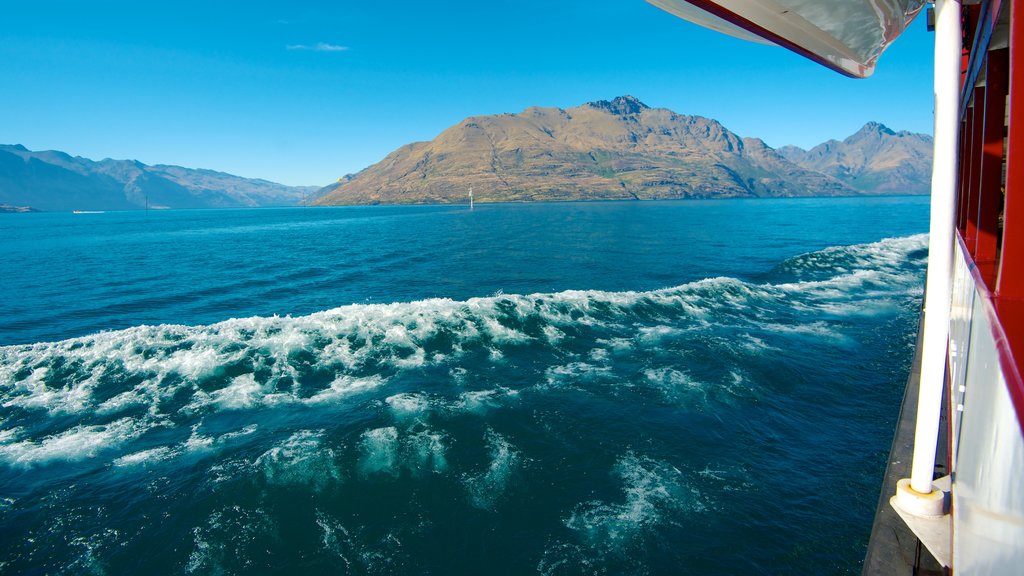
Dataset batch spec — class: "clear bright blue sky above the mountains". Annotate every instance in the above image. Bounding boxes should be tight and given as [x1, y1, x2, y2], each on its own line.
[0, 0, 933, 184]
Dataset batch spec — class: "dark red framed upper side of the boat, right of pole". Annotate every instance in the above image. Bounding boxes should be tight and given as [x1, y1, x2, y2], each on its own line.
[955, 0, 1024, 434]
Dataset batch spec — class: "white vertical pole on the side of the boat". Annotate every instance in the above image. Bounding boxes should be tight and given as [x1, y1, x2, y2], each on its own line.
[910, 0, 961, 494]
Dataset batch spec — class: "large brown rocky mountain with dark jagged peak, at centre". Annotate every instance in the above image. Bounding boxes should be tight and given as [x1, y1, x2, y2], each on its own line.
[317, 96, 862, 205]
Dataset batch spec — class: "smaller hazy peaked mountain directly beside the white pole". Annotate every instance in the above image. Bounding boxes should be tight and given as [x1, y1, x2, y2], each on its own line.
[777, 122, 932, 194]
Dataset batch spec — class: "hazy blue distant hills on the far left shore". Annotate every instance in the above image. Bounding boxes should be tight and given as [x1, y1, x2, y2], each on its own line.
[0, 145, 317, 210]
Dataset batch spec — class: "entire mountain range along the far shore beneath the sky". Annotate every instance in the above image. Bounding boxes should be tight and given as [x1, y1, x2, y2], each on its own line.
[0, 96, 932, 211]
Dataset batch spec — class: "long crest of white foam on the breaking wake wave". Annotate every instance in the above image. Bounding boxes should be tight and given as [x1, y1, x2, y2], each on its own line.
[0, 230, 927, 463]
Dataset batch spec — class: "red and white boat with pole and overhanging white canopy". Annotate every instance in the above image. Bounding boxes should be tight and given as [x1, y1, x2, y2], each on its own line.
[647, 0, 1024, 576]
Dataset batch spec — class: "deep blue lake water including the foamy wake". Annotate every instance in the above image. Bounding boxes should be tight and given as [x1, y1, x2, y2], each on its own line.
[0, 197, 928, 574]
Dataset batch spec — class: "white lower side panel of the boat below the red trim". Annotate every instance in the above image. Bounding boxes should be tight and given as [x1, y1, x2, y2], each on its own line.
[949, 230, 1024, 575]
